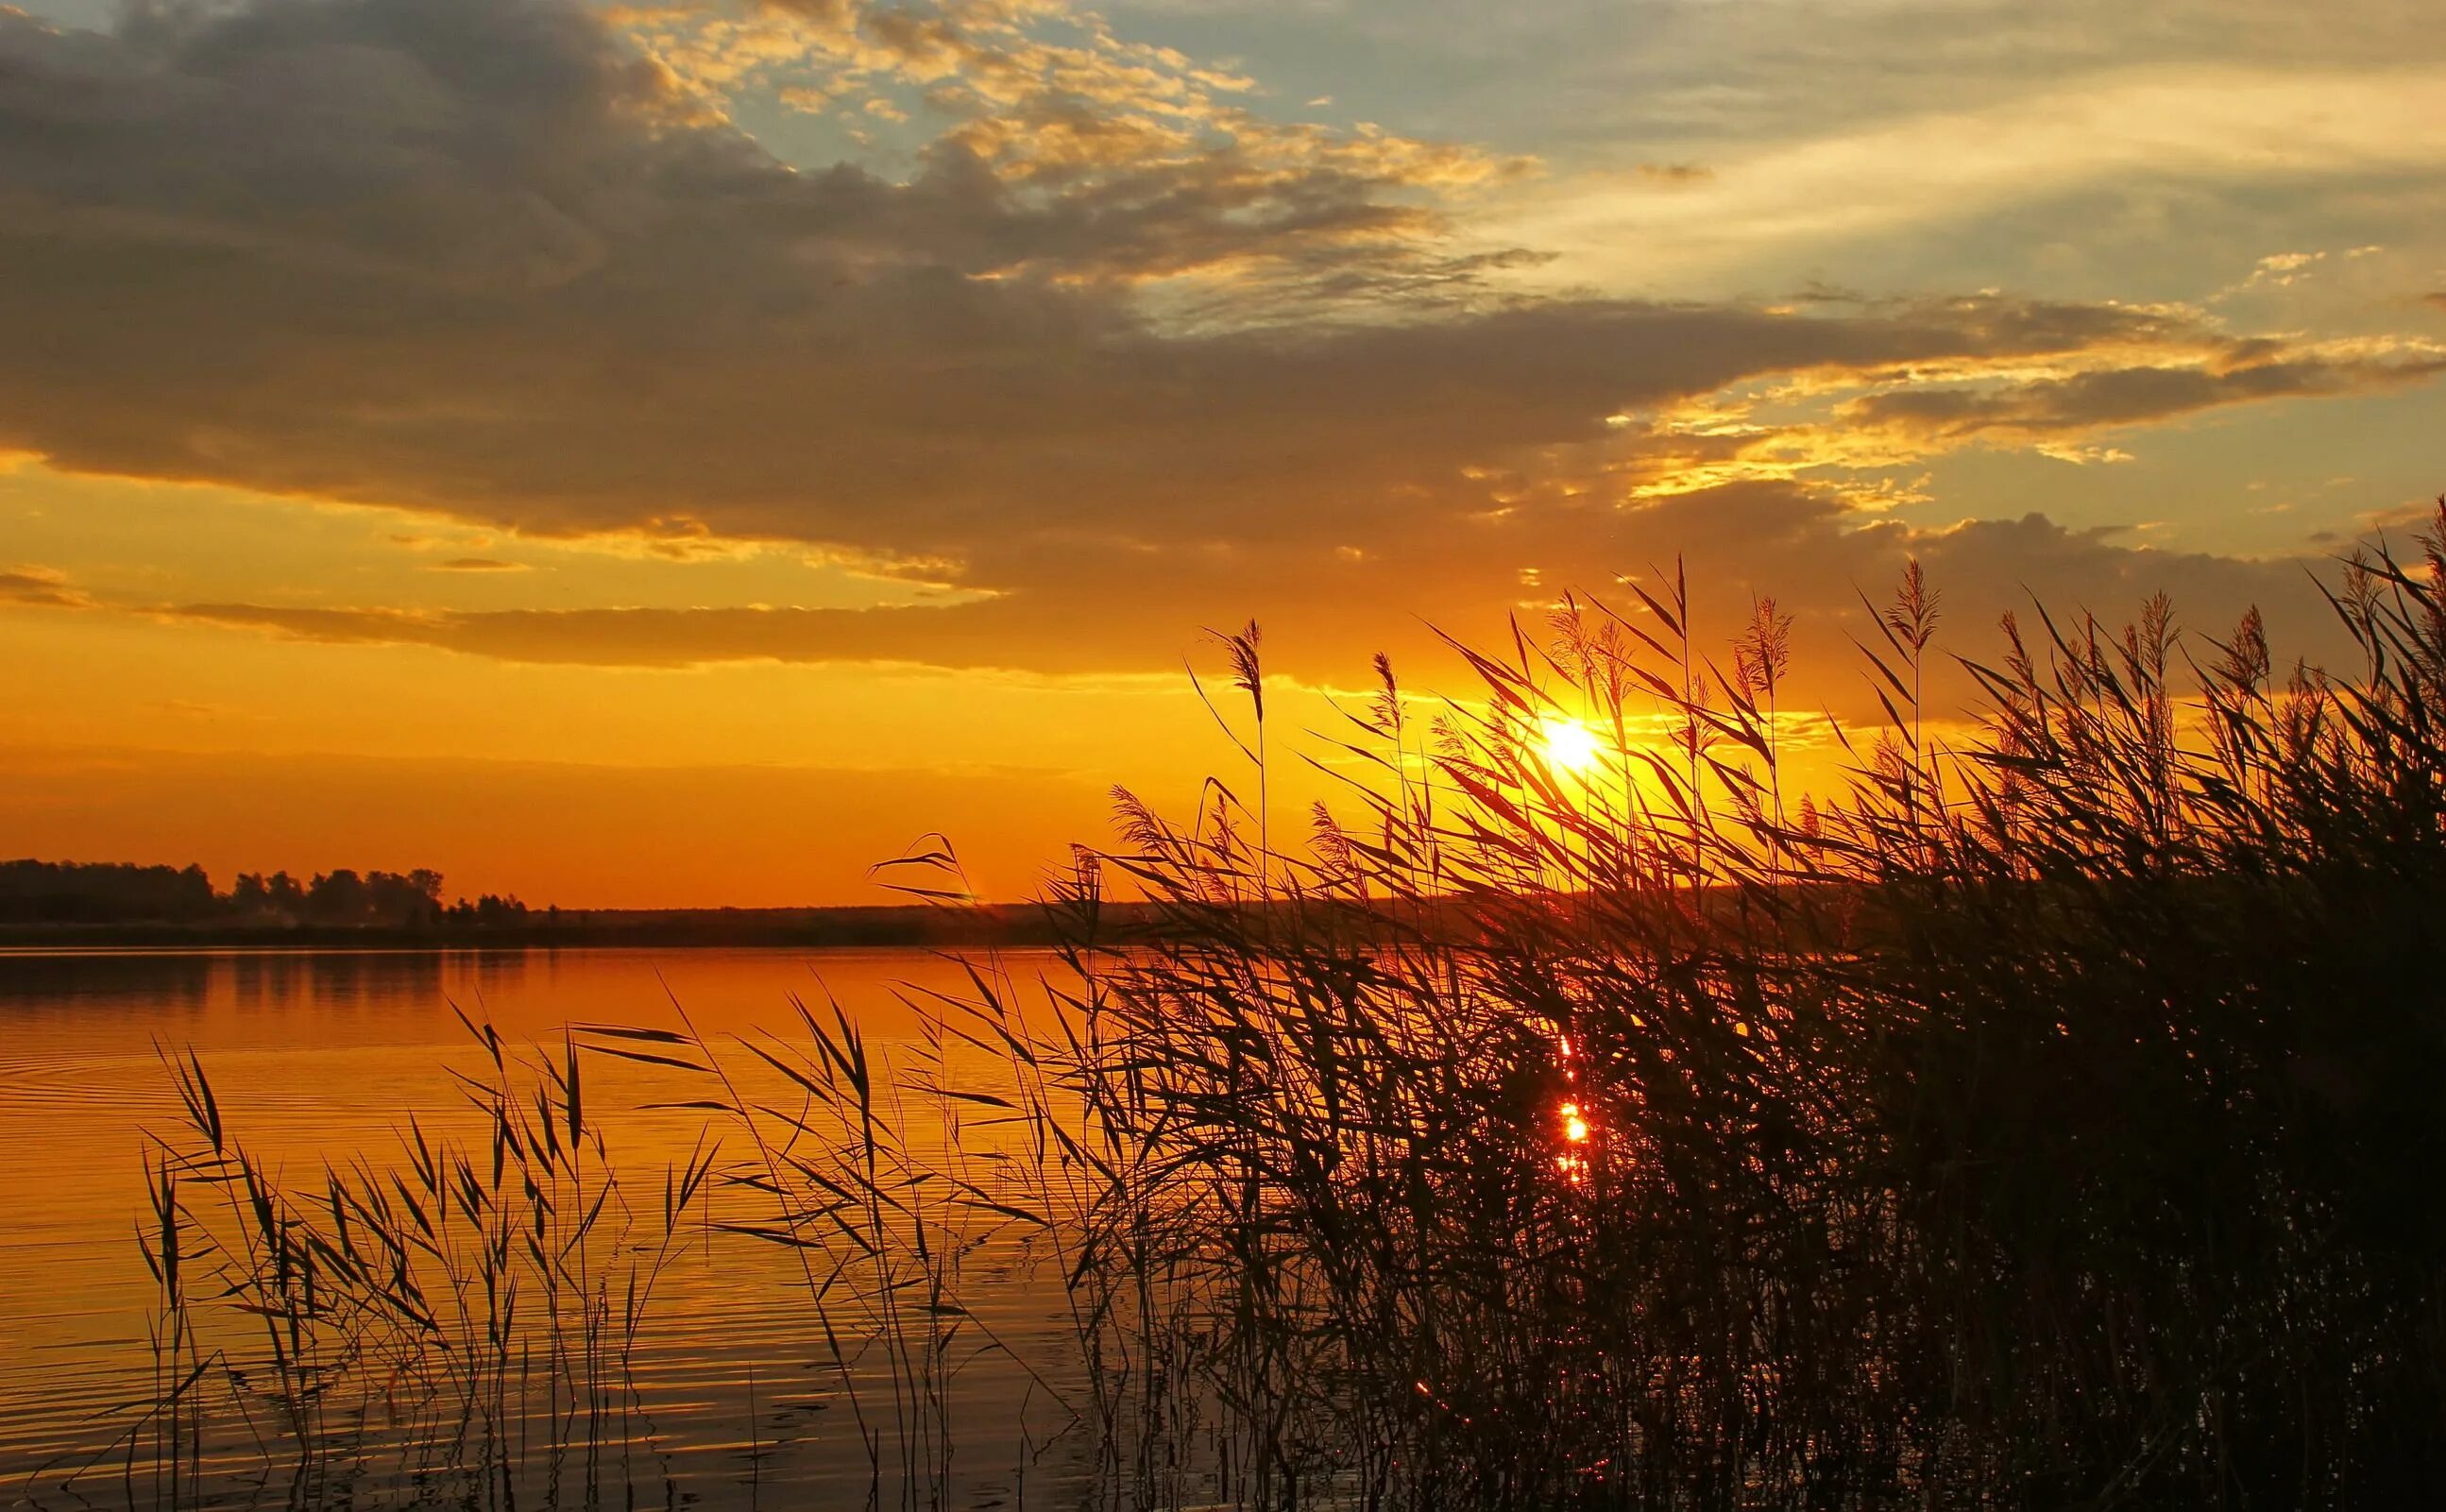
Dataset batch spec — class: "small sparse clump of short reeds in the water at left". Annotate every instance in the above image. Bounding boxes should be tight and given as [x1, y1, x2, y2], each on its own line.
[95, 1023, 717, 1507]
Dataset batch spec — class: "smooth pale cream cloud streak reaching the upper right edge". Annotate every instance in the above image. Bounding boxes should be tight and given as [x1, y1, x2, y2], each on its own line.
[1489, 64, 2446, 281]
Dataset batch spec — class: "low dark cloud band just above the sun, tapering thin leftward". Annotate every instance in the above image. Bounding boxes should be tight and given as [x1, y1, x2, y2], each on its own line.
[164, 484, 2341, 717]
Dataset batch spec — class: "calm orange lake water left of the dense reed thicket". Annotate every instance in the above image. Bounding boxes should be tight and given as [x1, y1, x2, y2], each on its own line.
[0, 949, 1086, 1507]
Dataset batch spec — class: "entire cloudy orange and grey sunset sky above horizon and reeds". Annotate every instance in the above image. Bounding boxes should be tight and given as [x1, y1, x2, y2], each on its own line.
[0, 0, 2446, 906]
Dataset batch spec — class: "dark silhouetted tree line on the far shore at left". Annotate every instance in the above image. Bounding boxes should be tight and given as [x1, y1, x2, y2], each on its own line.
[0, 861, 537, 929]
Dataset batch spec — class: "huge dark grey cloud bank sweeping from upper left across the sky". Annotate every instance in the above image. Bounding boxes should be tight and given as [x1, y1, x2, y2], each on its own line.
[0, 0, 2426, 668]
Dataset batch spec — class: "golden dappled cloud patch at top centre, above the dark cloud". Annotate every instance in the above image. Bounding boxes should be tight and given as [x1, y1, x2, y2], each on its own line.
[619, 0, 1529, 301]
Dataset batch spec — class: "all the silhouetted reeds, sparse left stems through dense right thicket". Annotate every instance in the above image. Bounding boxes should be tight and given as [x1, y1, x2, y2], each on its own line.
[124, 501, 2446, 1509]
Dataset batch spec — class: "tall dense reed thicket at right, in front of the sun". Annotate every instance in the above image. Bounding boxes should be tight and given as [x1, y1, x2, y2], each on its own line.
[959, 496, 2446, 1507]
